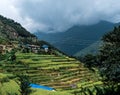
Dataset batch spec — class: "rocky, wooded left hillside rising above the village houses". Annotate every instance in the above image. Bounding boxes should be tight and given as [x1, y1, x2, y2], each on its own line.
[0, 15, 59, 53]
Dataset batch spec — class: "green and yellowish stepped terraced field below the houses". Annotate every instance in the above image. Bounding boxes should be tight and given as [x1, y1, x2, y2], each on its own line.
[1, 53, 101, 91]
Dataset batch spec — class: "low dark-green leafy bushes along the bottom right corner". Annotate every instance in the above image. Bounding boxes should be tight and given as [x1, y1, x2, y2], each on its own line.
[73, 85, 120, 95]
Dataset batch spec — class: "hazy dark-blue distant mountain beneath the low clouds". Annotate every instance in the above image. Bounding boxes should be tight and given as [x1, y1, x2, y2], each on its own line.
[35, 21, 118, 55]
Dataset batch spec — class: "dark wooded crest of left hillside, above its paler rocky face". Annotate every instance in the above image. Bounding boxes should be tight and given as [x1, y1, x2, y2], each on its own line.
[0, 15, 35, 37]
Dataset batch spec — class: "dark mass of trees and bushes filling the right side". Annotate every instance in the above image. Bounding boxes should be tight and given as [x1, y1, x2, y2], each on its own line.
[76, 27, 120, 95]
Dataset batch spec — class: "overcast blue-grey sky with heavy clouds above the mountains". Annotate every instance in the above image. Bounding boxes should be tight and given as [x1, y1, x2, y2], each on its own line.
[0, 0, 120, 32]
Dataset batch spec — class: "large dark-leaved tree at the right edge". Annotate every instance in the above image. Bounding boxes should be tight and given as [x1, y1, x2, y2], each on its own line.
[99, 27, 120, 83]
